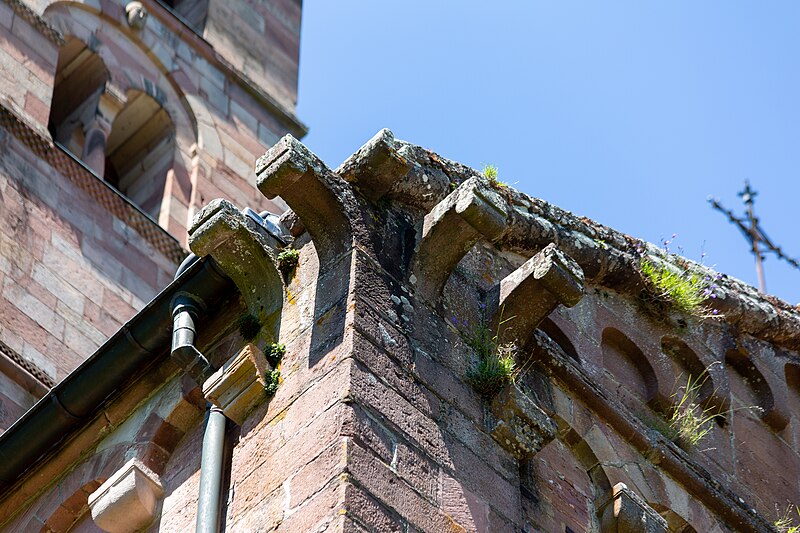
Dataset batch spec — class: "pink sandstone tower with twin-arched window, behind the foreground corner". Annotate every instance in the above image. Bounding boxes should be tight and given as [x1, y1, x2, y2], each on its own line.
[0, 0, 305, 430]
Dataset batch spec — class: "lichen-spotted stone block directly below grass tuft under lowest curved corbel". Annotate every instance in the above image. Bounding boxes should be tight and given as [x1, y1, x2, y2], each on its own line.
[489, 383, 558, 460]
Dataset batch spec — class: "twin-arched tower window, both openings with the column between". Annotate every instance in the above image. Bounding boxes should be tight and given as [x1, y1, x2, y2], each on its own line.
[49, 37, 175, 218]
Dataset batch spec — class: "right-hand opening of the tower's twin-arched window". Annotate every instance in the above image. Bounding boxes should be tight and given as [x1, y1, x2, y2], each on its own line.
[103, 90, 175, 217]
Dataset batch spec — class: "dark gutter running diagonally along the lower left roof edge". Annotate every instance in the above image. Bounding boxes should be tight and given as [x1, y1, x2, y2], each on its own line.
[0, 257, 238, 496]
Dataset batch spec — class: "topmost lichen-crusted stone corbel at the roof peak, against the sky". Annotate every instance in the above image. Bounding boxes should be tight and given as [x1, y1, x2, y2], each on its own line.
[336, 128, 413, 202]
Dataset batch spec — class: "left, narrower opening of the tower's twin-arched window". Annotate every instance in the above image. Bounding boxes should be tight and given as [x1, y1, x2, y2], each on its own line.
[48, 36, 109, 155]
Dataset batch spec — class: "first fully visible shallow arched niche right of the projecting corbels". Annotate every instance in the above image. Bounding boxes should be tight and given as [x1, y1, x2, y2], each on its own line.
[601, 327, 658, 411]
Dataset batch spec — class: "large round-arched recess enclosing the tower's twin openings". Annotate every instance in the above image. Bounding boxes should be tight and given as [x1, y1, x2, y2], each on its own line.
[43, 1, 200, 233]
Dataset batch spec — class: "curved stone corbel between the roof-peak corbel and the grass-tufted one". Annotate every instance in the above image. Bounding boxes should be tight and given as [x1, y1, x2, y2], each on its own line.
[411, 178, 508, 302]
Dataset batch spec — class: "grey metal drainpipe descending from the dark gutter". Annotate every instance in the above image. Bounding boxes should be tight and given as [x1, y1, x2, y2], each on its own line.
[171, 254, 227, 533]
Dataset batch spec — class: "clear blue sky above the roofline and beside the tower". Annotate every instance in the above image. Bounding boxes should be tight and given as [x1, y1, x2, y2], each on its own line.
[297, 0, 800, 304]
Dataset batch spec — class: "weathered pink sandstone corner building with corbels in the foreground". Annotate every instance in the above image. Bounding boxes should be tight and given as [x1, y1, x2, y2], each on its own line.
[0, 130, 800, 533]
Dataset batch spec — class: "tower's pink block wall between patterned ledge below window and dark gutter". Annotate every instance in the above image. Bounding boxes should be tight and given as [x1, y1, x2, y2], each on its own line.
[0, 117, 175, 429]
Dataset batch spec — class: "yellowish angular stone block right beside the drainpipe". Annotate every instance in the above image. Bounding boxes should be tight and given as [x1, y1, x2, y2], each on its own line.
[203, 344, 270, 425]
